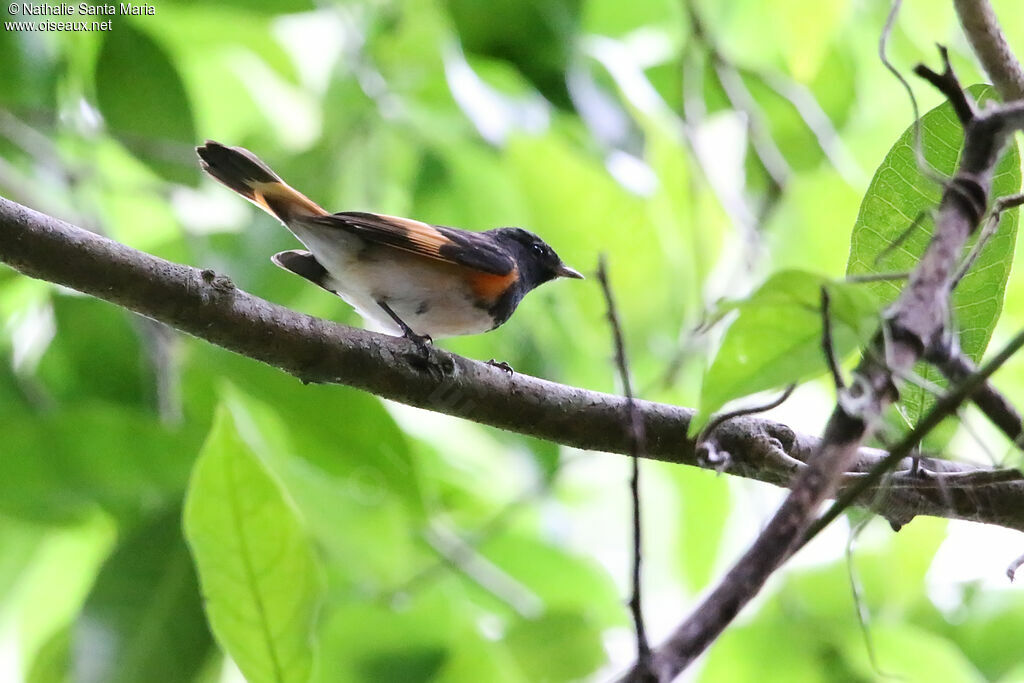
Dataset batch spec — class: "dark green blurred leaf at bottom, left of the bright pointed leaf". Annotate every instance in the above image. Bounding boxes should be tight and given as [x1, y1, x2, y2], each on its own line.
[73, 507, 213, 683]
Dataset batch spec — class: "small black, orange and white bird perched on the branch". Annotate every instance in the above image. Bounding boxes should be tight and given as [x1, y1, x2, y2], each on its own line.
[196, 140, 584, 352]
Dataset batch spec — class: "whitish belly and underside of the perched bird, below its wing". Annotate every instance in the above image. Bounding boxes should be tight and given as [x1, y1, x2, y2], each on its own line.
[292, 226, 495, 339]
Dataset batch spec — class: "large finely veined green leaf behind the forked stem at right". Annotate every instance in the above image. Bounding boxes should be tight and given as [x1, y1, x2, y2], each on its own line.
[847, 85, 1021, 423]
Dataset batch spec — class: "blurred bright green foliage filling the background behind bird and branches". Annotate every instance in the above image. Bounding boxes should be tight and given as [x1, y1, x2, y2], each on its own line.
[0, 0, 1024, 683]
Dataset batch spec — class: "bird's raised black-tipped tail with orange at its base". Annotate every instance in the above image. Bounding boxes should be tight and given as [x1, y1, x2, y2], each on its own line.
[196, 140, 328, 224]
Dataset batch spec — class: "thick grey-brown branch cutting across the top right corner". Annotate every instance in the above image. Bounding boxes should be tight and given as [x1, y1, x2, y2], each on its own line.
[953, 0, 1024, 102]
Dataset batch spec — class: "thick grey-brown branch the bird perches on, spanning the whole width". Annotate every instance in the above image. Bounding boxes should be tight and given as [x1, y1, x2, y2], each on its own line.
[0, 198, 1024, 520]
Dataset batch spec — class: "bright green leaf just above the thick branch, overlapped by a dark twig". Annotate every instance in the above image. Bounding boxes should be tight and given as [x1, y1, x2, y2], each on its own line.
[690, 270, 879, 433]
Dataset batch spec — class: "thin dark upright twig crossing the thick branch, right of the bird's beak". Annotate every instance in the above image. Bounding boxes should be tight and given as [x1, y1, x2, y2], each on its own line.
[597, 254, 656, 681]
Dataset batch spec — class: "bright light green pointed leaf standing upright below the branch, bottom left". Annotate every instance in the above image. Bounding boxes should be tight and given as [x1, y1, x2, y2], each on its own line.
[184, 409, 323, 683]
